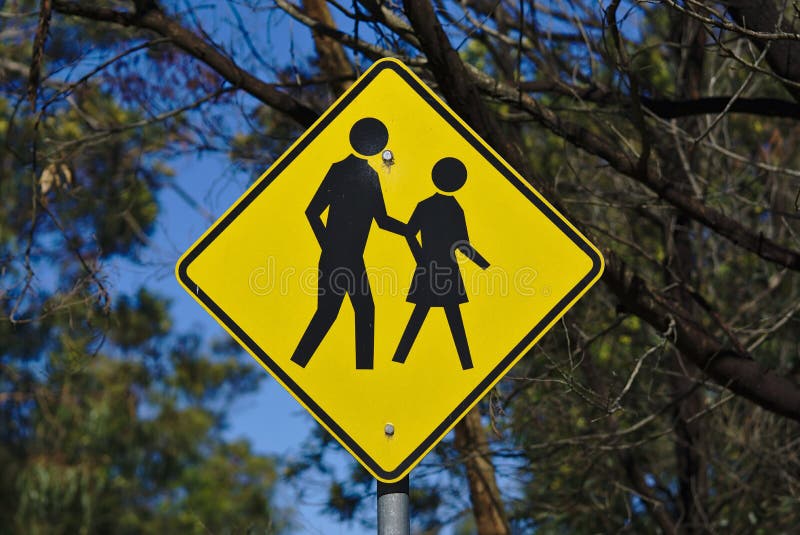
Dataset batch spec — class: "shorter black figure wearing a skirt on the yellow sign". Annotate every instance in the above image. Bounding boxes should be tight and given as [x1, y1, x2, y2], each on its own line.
[392, 158, 489, 370]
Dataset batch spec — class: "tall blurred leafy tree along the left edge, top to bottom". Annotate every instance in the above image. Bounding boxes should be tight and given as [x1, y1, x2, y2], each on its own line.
[0, 2, 291, 534]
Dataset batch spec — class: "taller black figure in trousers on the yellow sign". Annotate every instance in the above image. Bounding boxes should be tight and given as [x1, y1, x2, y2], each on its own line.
[292, 118, 406, 370]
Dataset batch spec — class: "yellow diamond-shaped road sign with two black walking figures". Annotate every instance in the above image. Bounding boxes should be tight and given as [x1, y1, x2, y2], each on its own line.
[177, 59, 603, 482]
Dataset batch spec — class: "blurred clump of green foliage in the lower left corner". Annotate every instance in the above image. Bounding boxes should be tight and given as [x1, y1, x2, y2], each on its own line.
[0, 291, 288, 534]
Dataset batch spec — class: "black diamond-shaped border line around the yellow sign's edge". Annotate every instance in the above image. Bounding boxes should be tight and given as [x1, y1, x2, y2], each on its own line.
[178, 60, 603, 481]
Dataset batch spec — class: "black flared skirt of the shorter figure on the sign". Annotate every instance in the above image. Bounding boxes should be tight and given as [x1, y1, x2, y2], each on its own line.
[406, 262, 469, 307]
